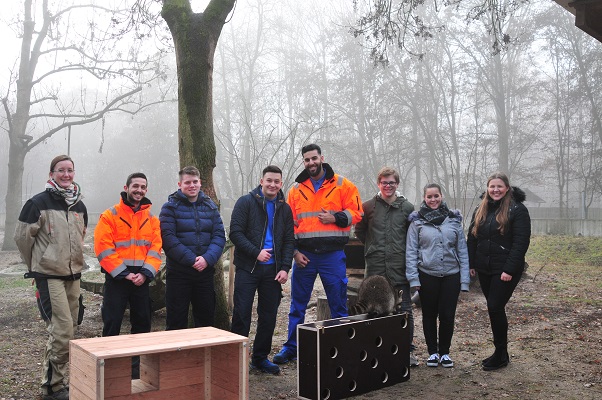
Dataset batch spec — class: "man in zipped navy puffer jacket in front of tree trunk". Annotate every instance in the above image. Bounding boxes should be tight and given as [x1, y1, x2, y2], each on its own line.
[159, 167, 226, 330]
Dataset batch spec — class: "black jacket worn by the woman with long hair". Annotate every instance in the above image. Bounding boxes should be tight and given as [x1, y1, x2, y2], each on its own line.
[467, 187, 531, 275]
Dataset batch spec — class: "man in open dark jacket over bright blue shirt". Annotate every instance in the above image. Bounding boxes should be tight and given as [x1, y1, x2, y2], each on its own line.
[230, 165, 295, 374]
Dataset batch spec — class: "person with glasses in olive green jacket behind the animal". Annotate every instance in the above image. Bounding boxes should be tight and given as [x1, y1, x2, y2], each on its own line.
[355, 167, 418, 366]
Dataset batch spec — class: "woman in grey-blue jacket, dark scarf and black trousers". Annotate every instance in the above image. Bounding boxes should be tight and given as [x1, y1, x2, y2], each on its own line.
[406, 183, 470, 368]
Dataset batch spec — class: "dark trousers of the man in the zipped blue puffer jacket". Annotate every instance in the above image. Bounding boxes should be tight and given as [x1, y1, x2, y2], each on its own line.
[165, 267, 215, 331]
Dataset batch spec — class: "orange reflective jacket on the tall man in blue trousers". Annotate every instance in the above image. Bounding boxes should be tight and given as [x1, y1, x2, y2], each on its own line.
[287, 163, 364, 253]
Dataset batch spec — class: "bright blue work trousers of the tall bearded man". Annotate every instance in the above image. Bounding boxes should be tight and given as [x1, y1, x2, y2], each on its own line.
[283, 250, 348, 351]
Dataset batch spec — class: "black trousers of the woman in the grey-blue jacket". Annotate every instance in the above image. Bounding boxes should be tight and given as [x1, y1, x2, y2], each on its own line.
[418, 270, 460, 355]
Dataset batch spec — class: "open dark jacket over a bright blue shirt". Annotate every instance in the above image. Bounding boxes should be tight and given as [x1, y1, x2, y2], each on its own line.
[230, 186, 295, 273]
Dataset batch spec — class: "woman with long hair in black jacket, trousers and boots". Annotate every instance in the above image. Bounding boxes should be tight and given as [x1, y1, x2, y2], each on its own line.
[467, 172, 531, 371]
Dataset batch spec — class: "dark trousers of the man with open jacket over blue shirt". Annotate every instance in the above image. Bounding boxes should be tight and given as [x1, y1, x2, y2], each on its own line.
[231, 264, 282, 365]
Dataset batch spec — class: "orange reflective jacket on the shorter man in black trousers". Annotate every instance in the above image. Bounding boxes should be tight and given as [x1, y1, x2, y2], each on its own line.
[94, 196, 162, 278]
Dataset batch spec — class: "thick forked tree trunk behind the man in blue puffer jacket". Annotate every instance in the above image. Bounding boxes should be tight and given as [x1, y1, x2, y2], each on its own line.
[161, 0, 235, 329]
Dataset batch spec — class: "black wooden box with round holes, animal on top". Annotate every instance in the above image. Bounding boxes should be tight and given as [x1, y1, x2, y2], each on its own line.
[297, 313, 410, 400]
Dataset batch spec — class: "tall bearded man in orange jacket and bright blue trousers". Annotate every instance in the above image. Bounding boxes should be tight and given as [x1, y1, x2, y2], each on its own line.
[274, 144, 363, 364]
